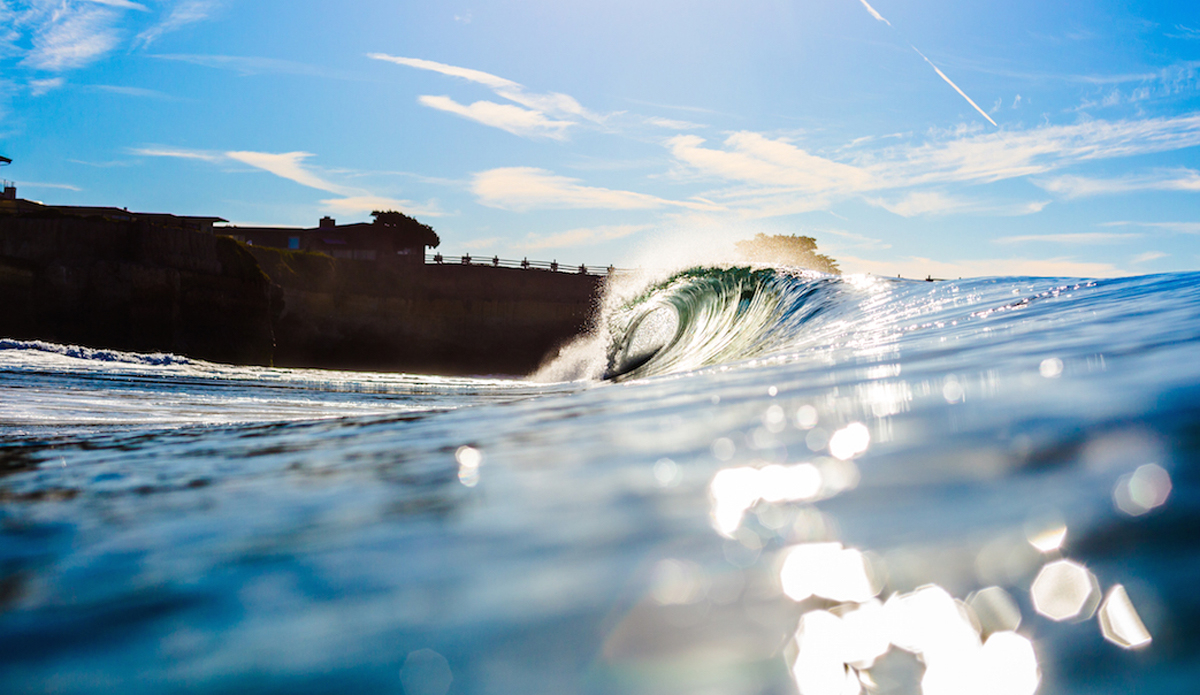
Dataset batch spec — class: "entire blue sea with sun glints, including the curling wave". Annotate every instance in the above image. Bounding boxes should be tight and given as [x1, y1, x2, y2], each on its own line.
[0, 269, 1200, 695]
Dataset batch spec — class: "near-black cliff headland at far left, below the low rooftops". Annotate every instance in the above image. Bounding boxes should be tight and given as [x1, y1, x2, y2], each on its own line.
[0, 215, 274, 365]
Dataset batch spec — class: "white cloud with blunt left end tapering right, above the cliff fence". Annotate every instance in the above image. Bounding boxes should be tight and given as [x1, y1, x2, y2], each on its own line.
[470, 167, 720, 211]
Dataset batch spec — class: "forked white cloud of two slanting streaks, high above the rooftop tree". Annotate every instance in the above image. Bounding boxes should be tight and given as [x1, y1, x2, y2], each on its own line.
[367, 53, 604, 139]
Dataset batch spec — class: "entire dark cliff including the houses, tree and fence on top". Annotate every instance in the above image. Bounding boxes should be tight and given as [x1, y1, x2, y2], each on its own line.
[0, 187, 605, 375]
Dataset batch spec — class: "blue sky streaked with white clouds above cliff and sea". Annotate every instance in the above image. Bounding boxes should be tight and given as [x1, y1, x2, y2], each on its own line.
[0, 0, 1200, 277]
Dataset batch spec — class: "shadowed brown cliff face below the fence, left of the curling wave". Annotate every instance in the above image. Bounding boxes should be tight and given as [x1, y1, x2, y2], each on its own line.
[250, 247, 602, 375]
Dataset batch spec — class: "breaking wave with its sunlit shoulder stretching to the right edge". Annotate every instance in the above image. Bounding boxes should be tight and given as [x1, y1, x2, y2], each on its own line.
[588, 266, 1198, 381]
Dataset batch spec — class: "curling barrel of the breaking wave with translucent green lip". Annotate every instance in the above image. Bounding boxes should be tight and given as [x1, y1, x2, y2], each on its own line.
[604, 268, 842, 379]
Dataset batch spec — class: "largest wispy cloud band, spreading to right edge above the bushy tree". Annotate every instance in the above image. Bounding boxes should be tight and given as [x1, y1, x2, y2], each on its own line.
[664, 114, 1200, 217]
